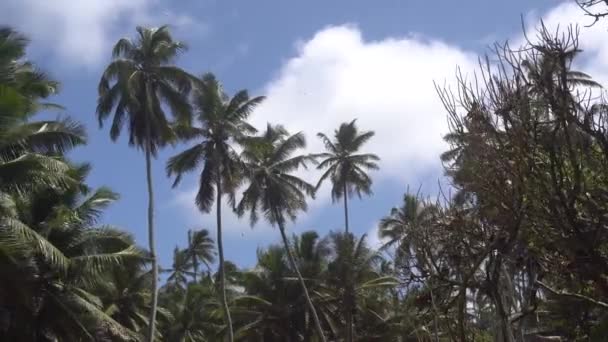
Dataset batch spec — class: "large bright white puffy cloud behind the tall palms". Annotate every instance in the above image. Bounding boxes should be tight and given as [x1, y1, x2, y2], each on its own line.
[253, 25, 476, 182]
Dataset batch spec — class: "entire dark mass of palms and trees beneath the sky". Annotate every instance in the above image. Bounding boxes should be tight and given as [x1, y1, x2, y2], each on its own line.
[0, 3, 608, 342]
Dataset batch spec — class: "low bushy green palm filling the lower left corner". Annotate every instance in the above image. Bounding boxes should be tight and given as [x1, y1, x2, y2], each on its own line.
[0, 167, 143, 341]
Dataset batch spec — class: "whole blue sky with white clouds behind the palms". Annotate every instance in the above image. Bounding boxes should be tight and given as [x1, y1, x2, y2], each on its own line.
[0, 0, 608, 266]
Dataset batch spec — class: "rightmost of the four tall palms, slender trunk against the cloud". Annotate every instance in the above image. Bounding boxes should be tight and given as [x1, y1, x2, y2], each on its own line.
[316, 120, 380, 233]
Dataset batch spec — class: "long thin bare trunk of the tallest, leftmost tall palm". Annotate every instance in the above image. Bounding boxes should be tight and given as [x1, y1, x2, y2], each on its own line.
[146, 129, 158, 342]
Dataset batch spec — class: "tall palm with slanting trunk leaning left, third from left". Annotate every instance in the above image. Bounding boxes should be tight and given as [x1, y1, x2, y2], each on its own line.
[236, 124, 325, 342]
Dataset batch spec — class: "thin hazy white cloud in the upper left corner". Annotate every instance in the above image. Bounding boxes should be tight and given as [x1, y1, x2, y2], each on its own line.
[0, 0, 204, 67]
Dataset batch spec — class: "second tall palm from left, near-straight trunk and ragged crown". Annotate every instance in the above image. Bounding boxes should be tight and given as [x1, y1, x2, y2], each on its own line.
[167, 74, 264, 342]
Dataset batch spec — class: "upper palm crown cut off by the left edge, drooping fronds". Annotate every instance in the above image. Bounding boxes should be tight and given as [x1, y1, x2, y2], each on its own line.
[0, 27, 86, 196]
